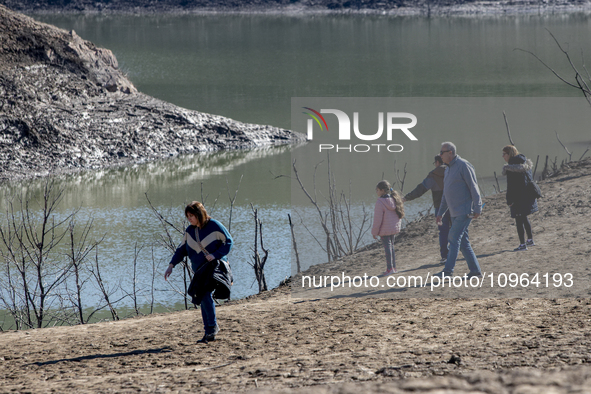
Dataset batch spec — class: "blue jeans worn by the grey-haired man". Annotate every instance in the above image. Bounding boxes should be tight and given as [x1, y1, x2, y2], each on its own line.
[443, 215, 481, 274]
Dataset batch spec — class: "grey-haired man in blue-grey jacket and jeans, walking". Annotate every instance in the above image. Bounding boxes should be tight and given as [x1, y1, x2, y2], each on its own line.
[435, 142, 482, 278]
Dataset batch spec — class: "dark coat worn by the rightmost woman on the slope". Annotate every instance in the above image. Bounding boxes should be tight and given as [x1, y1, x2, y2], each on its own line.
[503, 154, 538, 218]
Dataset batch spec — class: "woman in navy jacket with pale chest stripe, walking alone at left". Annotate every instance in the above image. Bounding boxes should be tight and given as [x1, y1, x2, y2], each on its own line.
[164, 201, 232, 342]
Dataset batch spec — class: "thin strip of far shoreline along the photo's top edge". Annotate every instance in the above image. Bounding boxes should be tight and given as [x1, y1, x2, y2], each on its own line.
[0, 0, 590, 14]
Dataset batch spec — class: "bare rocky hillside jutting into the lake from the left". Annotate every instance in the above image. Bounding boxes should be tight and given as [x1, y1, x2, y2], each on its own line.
[0, 6, 303, 179]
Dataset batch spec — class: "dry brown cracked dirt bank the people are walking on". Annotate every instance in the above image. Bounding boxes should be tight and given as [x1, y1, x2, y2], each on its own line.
[0, 160, 591, 394]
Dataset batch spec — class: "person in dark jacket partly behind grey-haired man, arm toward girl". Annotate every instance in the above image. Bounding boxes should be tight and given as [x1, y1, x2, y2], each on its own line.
[403, 155, 450, 264]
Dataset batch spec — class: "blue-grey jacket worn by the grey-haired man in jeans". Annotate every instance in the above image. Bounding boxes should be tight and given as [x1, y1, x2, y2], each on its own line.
[437, 155, 482, 218]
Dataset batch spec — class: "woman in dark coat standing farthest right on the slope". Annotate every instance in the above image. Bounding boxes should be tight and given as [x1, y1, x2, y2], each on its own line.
[503, 145, 538, 252]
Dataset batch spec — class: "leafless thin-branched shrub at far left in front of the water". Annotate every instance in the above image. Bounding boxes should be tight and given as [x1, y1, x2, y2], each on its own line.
[0, 180, 134, 329]
